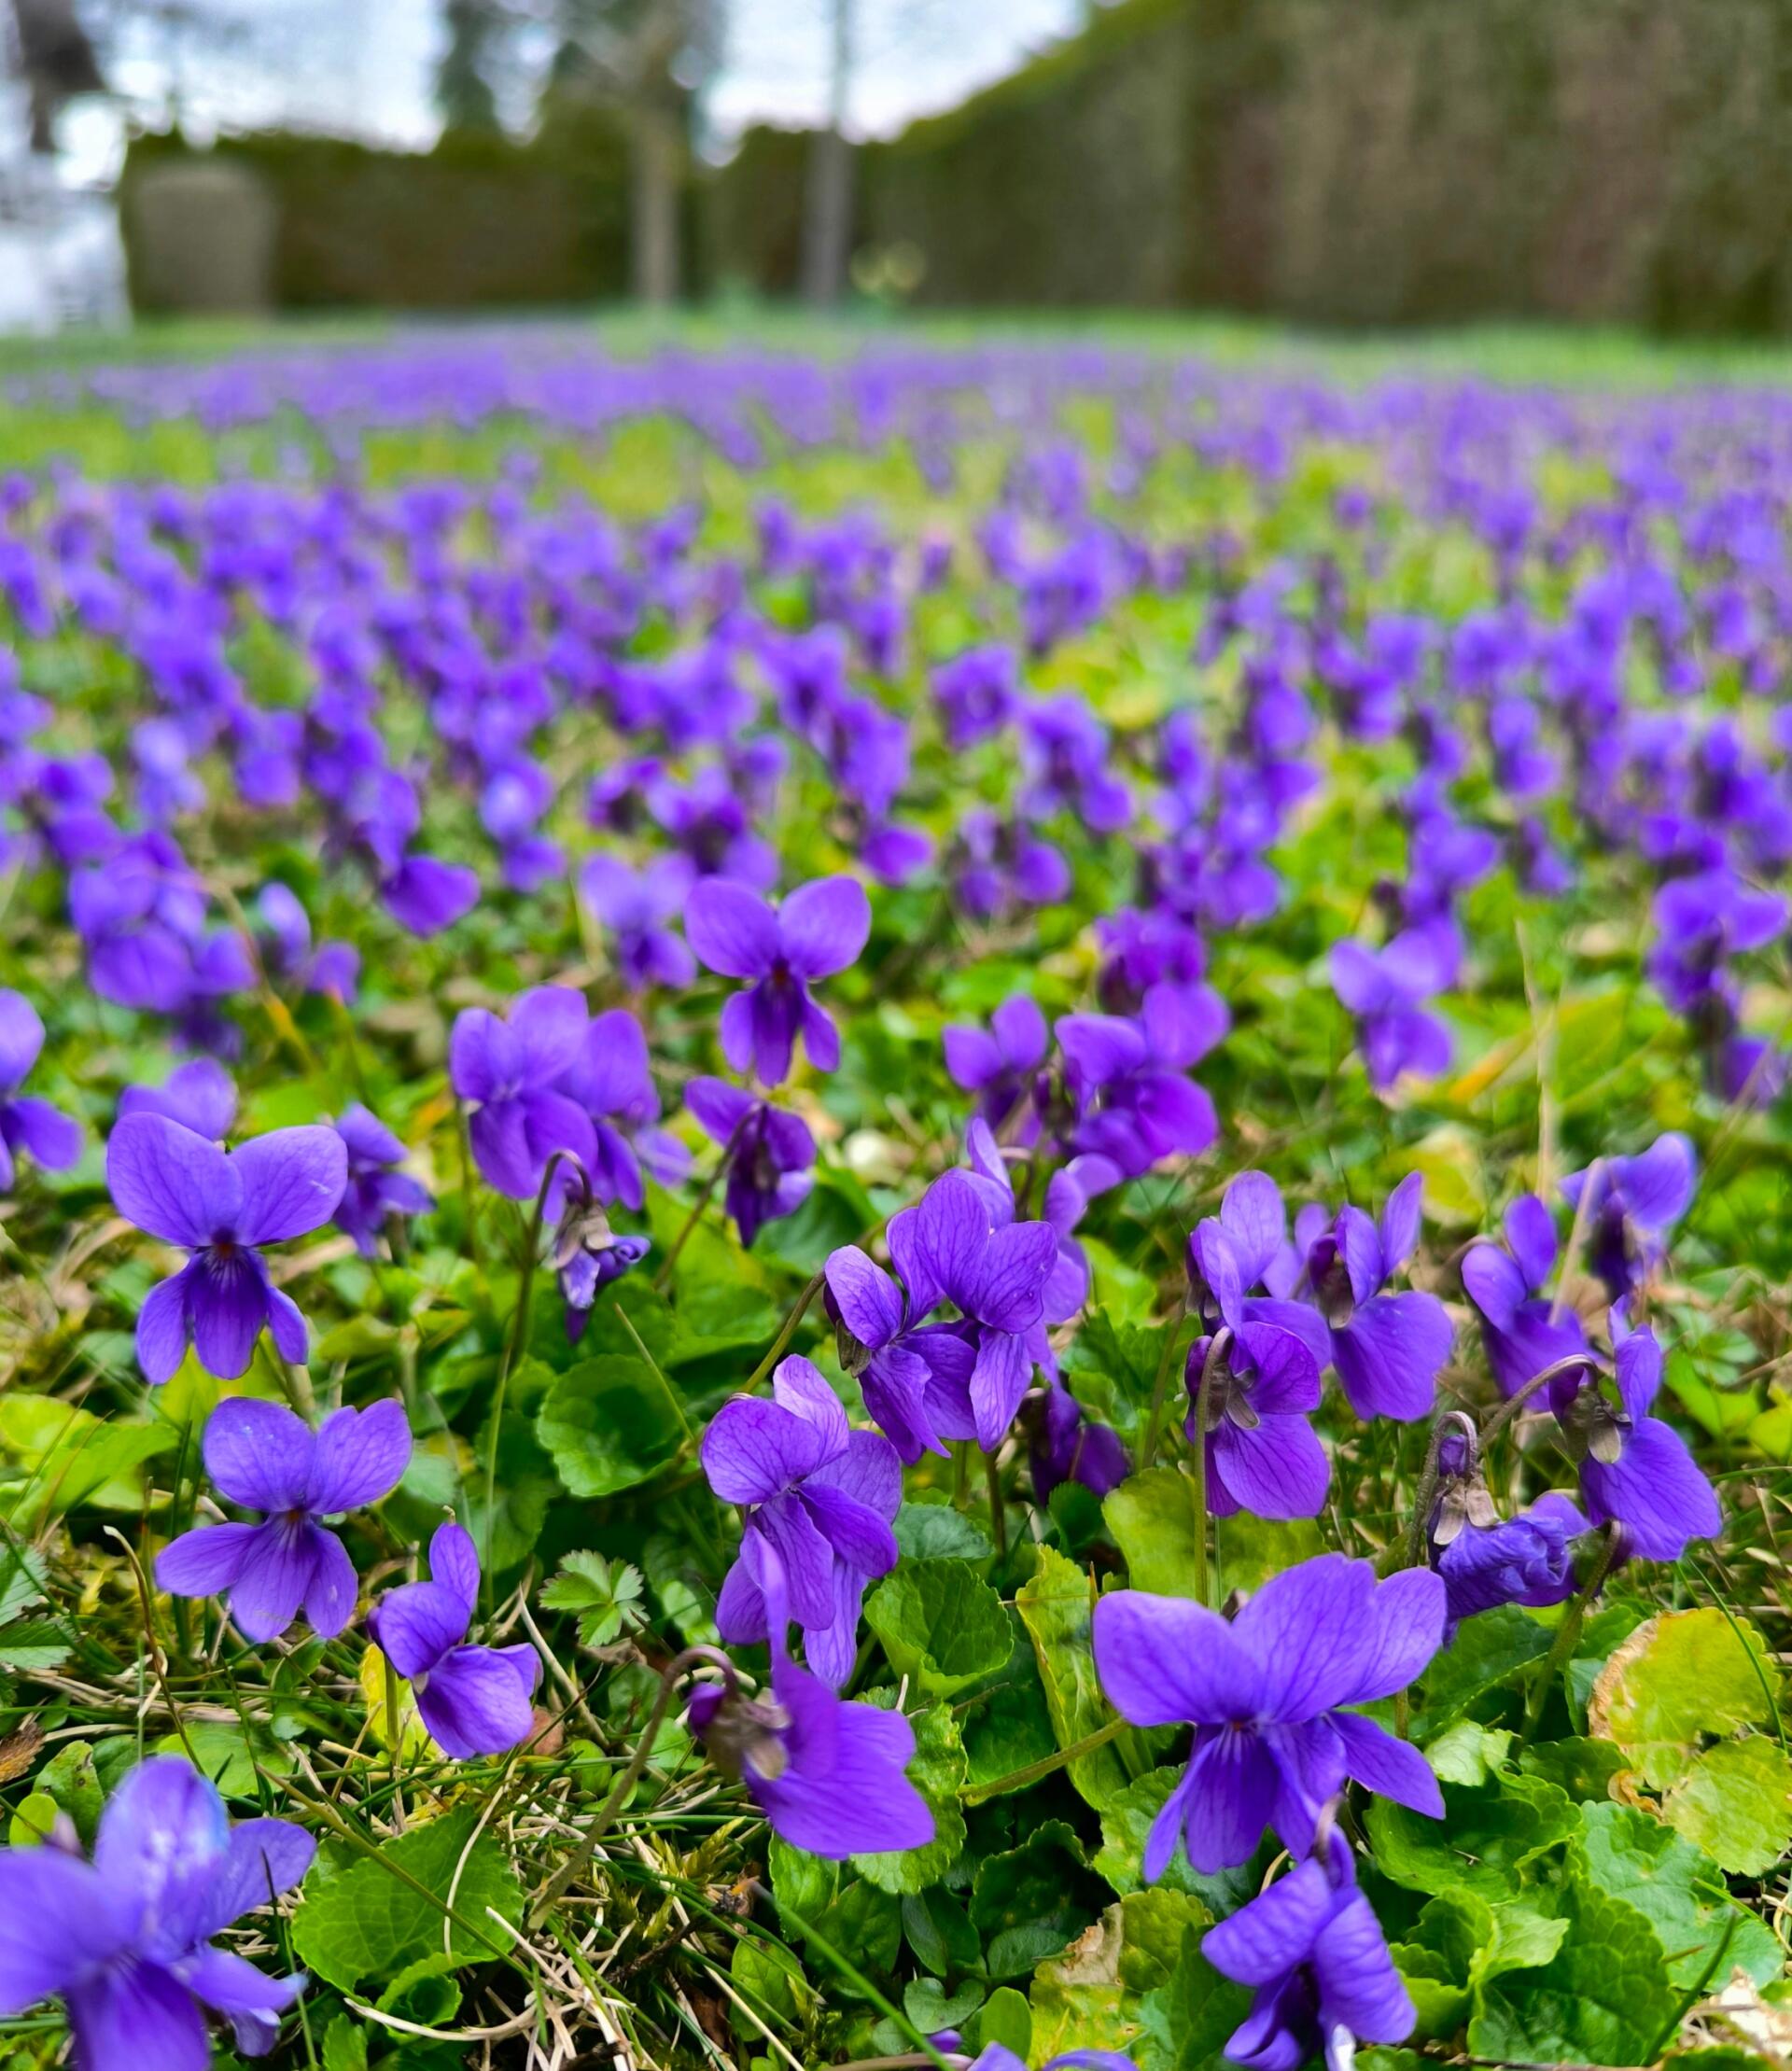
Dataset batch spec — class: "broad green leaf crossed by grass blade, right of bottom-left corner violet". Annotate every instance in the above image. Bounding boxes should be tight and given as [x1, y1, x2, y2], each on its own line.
[292, 1806, 522, 1993]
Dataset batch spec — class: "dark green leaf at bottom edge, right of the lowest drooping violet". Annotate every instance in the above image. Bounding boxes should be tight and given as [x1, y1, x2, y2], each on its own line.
[1469, 1876, 1680, 2064]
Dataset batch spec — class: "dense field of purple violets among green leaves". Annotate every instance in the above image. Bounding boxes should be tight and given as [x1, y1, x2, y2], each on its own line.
[0, 333, 1792, 2071]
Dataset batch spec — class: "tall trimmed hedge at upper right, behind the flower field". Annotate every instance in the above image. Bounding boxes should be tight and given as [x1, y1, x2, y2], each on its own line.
[715, 0, 1792, 331]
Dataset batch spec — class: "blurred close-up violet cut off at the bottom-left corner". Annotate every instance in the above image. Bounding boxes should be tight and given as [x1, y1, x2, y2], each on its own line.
[0, 1754, 317, 2071]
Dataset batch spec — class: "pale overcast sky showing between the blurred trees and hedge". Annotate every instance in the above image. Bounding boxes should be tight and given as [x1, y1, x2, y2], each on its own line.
[64, 0, 1085, 178]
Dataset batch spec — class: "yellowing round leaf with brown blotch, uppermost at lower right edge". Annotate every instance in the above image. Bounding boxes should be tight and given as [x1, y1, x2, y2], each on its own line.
[1587, 1609, 1780, 1789]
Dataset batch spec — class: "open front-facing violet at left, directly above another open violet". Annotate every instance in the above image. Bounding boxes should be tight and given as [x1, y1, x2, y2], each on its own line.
[105, 1114, 348, 1383]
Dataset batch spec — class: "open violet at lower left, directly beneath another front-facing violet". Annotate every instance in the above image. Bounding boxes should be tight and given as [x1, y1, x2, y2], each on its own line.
[155, 1396, 410, 1644]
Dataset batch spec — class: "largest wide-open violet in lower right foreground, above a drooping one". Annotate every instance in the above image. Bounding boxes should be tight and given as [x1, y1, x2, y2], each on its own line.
[1094, 1553, 1446, 1882]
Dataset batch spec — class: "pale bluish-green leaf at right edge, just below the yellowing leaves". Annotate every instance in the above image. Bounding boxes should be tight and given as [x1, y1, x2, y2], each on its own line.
[1568, 1804, 1784, 1993]
